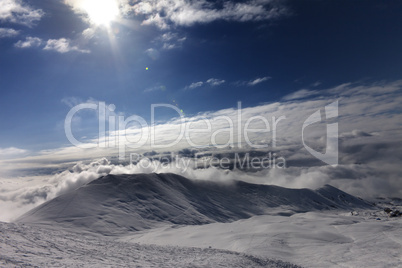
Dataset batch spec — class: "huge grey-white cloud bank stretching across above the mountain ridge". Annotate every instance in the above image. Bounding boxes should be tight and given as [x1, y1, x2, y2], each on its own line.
[0, 80, 402, 217]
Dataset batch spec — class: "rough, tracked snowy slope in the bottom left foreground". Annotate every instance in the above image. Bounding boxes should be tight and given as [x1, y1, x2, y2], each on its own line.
[0, 222, 297, 268]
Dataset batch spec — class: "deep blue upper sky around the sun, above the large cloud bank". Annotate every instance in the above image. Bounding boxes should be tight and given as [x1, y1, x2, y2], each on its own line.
[0, 0, 402, 151]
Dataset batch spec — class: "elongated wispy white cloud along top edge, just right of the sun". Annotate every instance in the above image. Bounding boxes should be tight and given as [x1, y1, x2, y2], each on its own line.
[129, 0, 288, 29]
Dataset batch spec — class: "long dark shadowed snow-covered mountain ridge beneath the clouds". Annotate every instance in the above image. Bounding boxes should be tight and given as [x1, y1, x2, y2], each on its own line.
[17, 174, 371, 235]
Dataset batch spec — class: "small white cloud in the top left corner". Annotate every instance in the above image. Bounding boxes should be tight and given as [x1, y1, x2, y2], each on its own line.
[0, 0, 45, 27]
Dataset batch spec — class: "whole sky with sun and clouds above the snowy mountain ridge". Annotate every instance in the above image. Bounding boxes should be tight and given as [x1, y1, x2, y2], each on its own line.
[0, 0, 402, 220]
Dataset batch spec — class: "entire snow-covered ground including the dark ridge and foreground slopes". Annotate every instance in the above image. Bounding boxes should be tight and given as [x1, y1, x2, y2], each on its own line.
[0, 174, 402, 267]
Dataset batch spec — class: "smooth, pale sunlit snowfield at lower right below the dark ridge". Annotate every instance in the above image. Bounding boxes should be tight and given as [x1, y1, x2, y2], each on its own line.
[120, 210, 402, 268]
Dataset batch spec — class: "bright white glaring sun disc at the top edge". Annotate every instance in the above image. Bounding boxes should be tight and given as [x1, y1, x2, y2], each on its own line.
[81, 0, 119, 26]
